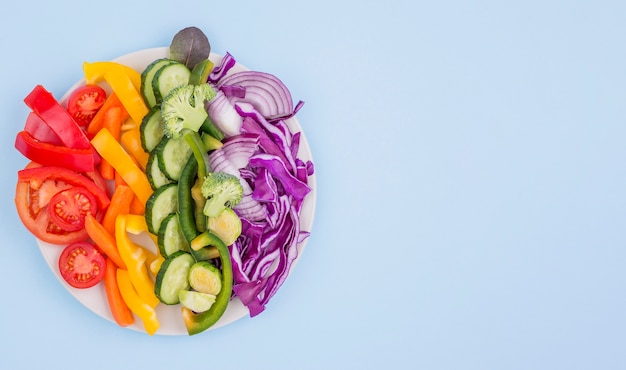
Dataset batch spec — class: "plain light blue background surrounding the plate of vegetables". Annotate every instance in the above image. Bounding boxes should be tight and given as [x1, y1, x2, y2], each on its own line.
[0, 0, 626, 370]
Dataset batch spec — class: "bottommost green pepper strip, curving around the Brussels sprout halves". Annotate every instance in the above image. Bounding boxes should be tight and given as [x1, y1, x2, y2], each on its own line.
[182, 230, 233, 335]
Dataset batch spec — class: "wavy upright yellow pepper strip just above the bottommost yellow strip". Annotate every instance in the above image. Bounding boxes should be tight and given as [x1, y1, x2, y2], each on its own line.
[115, 215, 159, 307]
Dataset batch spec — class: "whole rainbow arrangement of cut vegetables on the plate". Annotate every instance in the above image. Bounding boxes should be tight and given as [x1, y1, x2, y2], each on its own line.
[15, 27, 314, 335]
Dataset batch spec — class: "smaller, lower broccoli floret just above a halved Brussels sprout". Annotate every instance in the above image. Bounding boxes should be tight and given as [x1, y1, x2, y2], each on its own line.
[201, 172, 243, 217]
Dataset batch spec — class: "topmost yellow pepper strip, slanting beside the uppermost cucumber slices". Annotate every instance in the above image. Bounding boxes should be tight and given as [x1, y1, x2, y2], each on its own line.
[104, 65, 149, 124]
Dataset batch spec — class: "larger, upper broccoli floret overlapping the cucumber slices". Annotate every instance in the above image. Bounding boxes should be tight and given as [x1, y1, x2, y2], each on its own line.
[161, 84, 216, 137]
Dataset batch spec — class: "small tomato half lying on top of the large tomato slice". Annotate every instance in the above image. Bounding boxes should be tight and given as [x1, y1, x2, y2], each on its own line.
[47, 186, 98, 231]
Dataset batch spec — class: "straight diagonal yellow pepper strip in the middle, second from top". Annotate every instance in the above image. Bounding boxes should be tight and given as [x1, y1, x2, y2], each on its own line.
[91, 128, 153, 204]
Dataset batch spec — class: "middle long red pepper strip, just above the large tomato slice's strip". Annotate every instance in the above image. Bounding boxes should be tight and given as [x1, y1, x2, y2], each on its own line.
[15, 130, 96, 172]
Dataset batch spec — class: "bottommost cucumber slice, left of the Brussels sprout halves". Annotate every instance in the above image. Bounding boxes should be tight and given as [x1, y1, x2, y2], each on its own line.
[154, 251, 196, 305]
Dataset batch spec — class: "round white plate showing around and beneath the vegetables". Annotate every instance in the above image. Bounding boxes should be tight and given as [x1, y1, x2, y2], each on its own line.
[37, 47, 316, 335]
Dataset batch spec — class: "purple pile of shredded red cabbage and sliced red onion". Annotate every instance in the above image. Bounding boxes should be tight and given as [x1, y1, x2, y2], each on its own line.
[207, 54, 314, 317]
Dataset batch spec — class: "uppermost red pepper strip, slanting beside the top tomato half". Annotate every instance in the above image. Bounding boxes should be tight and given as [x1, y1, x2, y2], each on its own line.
[24, 85, 91, 149]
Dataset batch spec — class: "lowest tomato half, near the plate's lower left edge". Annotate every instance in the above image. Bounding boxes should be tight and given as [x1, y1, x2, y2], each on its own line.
[59, 242, 106, 289]
